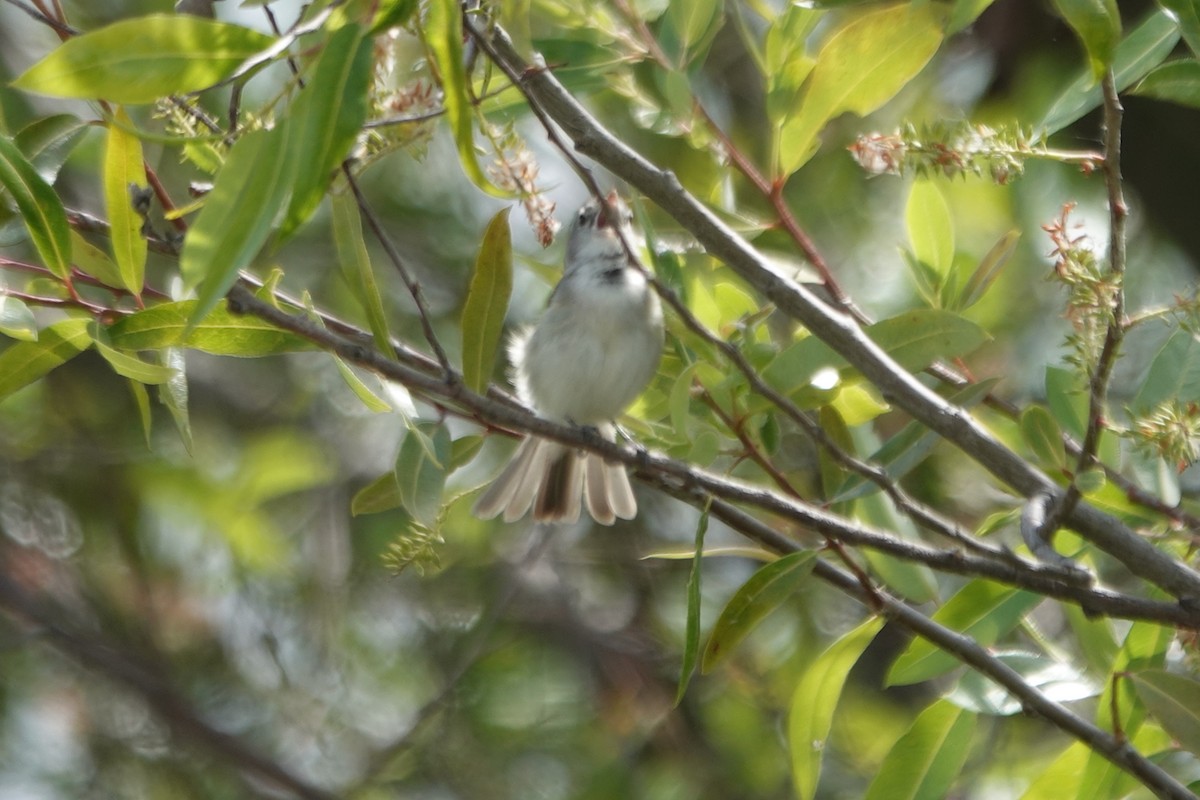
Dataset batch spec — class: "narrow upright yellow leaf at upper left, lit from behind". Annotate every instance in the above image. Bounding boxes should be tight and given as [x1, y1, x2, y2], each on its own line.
[104, 108, 146, 296]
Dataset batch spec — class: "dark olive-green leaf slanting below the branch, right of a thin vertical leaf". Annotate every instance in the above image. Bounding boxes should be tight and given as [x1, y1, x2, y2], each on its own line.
[700, 551, 816, 674]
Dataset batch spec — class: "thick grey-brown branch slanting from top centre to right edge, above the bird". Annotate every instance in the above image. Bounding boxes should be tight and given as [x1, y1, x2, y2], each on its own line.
[468, 23, 1200, 606]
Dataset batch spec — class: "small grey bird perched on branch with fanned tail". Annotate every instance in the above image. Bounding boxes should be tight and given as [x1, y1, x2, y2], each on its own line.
[474, 192, 662, 525]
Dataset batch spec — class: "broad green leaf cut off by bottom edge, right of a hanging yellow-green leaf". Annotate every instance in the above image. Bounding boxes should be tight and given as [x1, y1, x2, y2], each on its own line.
[866, 700, 976, 800]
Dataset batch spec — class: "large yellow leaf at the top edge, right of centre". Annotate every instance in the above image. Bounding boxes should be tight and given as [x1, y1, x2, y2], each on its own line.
[779, 2, 943, 175]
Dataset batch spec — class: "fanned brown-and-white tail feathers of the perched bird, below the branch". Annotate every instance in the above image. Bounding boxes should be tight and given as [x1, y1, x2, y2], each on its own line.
[474, 437, 637, 525]
